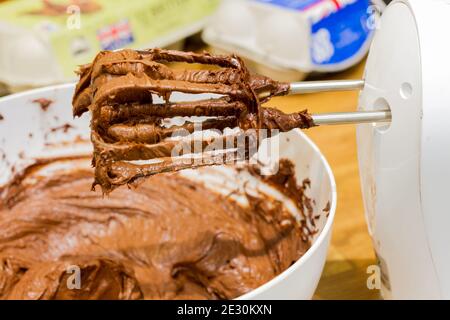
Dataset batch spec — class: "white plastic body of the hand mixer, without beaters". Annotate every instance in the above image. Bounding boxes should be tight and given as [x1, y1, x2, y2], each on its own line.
[357, 0, 450, 299]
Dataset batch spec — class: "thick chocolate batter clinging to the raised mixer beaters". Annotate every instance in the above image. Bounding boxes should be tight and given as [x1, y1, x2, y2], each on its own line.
[72, 49, 314, 193]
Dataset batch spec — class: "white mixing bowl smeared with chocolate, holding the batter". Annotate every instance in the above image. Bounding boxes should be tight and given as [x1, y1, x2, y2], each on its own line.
[0, 84, 336, 299]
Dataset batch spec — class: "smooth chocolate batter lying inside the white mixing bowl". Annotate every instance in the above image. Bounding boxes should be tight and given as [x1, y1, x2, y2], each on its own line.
[0, 159, 310, 299]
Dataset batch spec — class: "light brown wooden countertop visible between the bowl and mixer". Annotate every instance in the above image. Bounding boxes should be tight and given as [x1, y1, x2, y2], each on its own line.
[269, 63, 380, 299]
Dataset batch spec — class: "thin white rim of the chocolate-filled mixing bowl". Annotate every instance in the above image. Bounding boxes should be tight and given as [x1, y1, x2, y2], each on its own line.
[0, 82, 337, 300]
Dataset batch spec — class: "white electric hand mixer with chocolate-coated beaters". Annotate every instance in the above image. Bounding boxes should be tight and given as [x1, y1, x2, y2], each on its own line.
[74, 0, 450, 298]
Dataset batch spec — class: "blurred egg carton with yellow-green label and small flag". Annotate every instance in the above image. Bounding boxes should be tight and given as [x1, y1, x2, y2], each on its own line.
[0, 0, 219, 90]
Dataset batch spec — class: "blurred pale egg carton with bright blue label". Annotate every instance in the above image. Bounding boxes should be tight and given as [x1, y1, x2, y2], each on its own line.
[203, 0, 382, 79]
